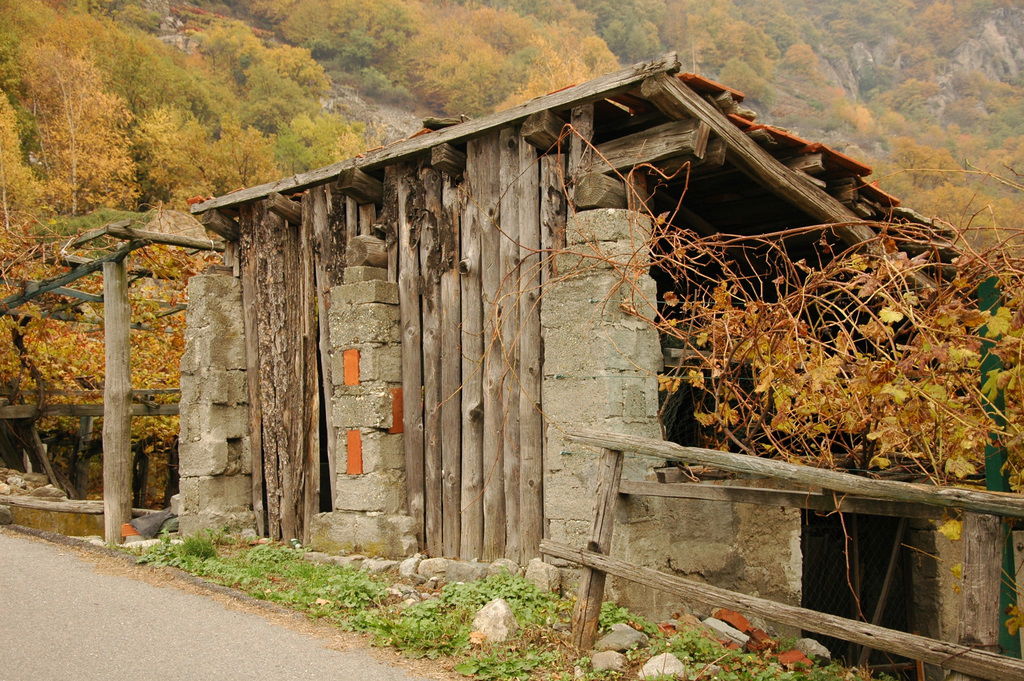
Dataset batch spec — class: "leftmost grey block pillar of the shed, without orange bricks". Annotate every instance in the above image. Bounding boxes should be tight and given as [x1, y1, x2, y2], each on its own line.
[178, 273, 255, 535]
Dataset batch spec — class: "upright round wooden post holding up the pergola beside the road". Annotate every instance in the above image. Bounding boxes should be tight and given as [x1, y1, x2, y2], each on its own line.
[103, 260, 131, 544]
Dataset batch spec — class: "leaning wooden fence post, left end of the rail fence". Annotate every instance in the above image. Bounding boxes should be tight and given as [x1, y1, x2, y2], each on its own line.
[572, 450, 623, 651]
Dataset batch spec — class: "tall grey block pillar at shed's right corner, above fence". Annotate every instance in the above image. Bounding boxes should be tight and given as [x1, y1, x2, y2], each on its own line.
[541, 204, 662, 547]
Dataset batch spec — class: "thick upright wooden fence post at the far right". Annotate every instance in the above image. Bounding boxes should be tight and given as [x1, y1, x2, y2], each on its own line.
[946, 513, 1005, 681]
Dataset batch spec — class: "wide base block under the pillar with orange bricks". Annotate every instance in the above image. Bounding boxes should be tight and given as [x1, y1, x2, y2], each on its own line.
[309, 511, 417, 558]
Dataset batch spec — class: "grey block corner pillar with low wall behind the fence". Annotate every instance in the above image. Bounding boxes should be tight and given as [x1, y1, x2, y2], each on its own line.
[541, 209, 802, 618]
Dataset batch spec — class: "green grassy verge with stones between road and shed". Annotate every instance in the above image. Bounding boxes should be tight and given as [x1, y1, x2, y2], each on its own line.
[139, 534, 886, 681]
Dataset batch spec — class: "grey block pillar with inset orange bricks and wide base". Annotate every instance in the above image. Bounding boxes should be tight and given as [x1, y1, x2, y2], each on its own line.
[310, 267, 417, 557]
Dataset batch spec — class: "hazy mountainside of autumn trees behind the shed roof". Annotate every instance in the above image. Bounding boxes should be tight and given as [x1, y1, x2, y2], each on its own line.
[0, 0, 1024, 226]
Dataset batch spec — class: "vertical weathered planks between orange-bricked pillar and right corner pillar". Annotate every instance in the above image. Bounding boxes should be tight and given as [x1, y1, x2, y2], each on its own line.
[393, 127, 566, 561]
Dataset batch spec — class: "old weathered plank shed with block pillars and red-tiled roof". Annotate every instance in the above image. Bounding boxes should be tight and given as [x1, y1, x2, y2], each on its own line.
[181, 54, 942, 560]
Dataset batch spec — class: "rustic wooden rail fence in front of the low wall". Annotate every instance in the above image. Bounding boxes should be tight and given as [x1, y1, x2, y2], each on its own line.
[541, 432, 1024, 681]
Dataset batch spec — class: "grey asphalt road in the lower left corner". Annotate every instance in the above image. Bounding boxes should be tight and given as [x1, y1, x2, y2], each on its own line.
[0, 530, 436, 681]
